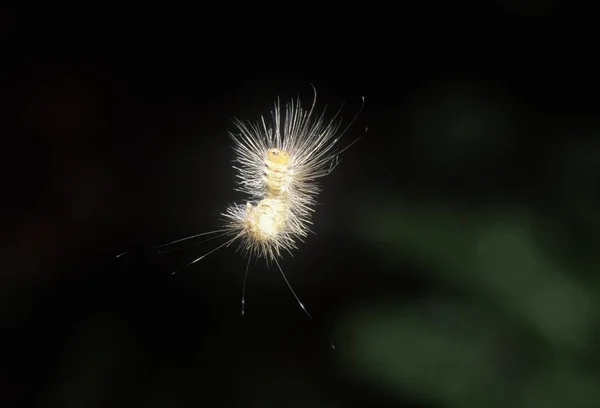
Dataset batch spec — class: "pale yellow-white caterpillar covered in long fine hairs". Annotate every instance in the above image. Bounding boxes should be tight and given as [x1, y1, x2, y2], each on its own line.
[121, 87, 364, 334]
